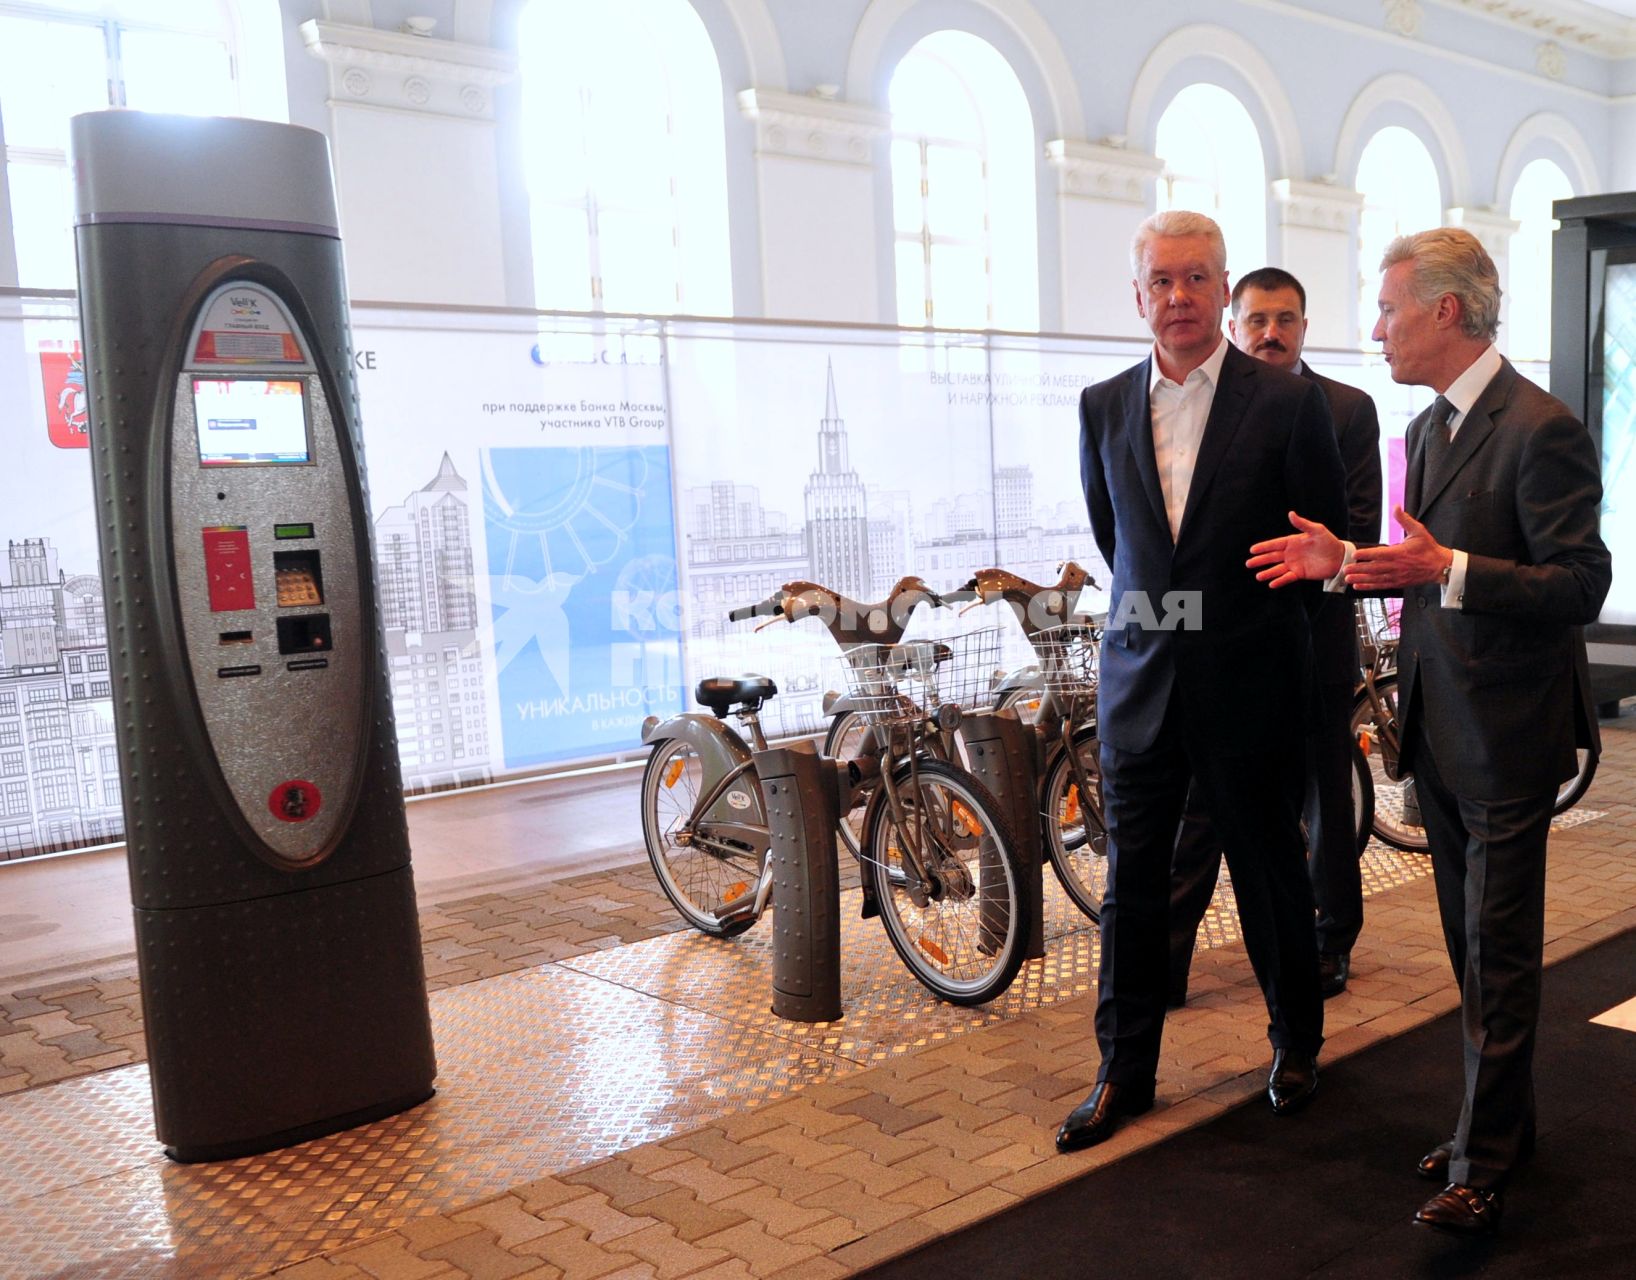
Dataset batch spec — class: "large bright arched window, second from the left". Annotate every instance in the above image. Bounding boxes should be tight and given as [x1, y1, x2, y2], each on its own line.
[519, 0, 733, 314]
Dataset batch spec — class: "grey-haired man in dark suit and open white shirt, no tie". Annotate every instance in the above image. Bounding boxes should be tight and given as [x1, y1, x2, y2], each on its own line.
[1057, 211, 1345, 1151]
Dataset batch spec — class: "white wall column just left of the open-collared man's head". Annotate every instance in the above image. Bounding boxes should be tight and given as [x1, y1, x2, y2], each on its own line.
[1045, 137, 1165, 337]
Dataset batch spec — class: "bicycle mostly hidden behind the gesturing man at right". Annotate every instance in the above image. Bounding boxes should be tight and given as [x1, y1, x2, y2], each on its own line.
[1351, 599, 1597, 853]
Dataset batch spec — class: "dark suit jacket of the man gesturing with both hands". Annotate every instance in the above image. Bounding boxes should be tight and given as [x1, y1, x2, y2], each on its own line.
[1397, 360, 1613, 800]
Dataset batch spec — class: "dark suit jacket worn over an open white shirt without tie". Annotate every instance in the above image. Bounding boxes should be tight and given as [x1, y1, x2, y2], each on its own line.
[1080, 345, 1346, 753]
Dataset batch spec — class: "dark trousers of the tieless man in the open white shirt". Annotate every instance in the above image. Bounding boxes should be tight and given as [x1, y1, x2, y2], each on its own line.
[1096, 692, 1324, 1085]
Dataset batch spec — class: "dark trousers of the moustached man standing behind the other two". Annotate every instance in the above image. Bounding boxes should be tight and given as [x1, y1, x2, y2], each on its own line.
[1170, 681, 1363, 994]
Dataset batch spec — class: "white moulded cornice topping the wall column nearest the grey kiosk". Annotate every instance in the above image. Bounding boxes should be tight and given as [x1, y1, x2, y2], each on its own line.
[301, 18, 517, 119]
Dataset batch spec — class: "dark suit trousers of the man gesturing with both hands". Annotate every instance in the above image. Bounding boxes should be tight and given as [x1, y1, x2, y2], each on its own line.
[1415, 720, 1556, 1188]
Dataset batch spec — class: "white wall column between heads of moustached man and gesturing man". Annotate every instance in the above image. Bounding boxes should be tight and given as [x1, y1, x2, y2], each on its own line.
[1273, 178, 1376, 347]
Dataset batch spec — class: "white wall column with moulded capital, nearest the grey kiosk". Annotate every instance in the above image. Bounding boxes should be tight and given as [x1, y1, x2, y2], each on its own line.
[301, 18, 515, 306]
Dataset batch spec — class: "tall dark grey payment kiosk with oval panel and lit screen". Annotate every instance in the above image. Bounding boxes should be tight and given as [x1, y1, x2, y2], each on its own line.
[72, 111, 437, 1161]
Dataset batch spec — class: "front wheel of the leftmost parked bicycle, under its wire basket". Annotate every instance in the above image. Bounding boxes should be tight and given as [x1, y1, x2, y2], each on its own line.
[862, 759, 1032, 1005]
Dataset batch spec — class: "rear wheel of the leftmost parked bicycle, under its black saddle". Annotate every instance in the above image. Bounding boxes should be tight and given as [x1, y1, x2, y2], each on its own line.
[641, 738, 767, 938]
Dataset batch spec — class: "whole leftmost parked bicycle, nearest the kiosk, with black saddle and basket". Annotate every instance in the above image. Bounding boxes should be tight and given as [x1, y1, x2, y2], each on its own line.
[641, 578, 1031, 1005]
